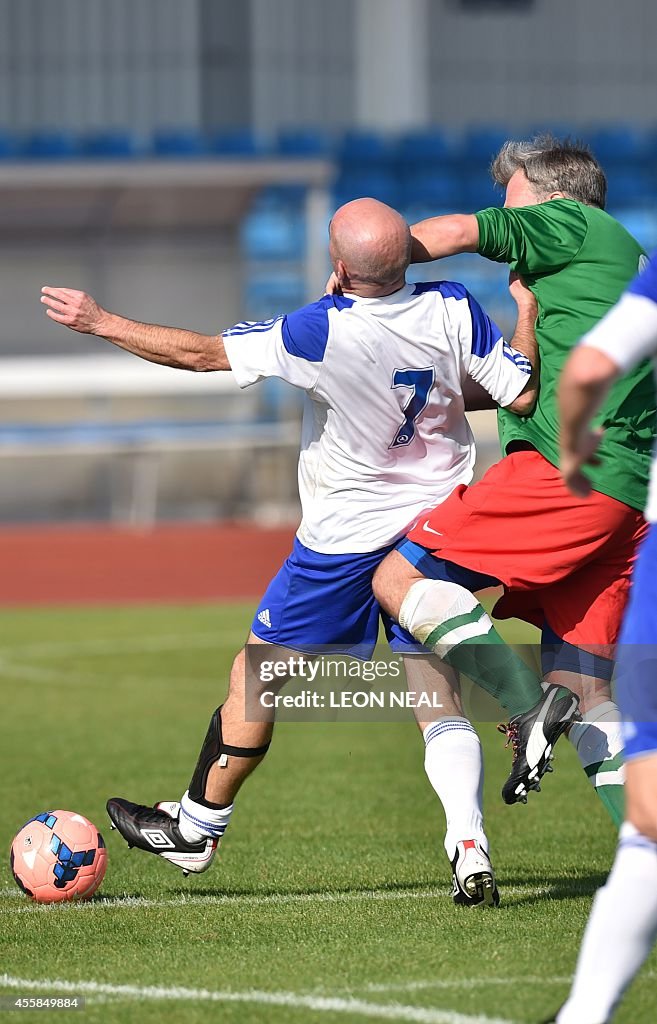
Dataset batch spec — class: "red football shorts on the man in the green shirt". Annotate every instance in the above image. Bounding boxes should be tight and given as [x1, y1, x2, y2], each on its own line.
[408, 451, 648, 646]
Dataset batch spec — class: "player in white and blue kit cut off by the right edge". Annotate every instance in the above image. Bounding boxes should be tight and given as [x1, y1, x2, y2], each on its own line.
[556, 253, 657, 1024]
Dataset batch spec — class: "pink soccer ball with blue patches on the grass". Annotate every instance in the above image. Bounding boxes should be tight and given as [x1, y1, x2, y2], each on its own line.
[10, 811, 107, 903]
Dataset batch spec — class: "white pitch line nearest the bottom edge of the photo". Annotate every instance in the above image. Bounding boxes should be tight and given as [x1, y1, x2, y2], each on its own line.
[0, 974, 513, 1024]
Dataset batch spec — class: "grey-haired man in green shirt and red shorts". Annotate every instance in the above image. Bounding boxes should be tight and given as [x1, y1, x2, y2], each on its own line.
[375, 137, 655, 824]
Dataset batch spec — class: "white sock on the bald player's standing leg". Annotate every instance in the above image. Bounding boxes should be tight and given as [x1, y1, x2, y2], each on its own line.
[423, 717, 488, 860]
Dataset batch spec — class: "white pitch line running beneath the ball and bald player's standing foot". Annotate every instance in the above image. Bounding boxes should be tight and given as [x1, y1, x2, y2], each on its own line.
[0, 886, 550, 915]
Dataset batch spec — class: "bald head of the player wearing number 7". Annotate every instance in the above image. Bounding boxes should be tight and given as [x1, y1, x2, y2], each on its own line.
[329, 199, 411, 296]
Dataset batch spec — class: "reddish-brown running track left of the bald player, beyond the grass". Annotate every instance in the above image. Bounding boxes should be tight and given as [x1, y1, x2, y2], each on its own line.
[0, 523, 294, 605]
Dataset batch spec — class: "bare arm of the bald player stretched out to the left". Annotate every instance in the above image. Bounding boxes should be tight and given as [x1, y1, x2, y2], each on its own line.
[41, 286, 230, 371]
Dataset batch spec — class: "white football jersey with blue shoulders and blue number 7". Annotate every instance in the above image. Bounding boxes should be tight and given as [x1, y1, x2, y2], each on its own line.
[223, 282, 531, 554]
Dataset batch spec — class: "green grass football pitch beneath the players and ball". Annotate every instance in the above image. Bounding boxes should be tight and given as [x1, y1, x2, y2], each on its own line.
[0, 605, 655, 1024]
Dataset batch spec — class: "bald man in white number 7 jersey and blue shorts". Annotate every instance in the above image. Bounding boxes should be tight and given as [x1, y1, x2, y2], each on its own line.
[42, 200, 537, 905]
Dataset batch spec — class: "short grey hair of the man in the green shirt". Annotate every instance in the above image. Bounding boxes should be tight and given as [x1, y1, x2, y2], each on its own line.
[490, 135, 607, 210]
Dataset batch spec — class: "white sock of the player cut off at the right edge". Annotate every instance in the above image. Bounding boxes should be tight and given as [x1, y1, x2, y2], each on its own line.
[557, 822, 657, 1024]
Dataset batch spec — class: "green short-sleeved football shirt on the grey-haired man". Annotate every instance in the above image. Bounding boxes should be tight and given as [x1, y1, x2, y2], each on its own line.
[476, 199, 656, 511]
